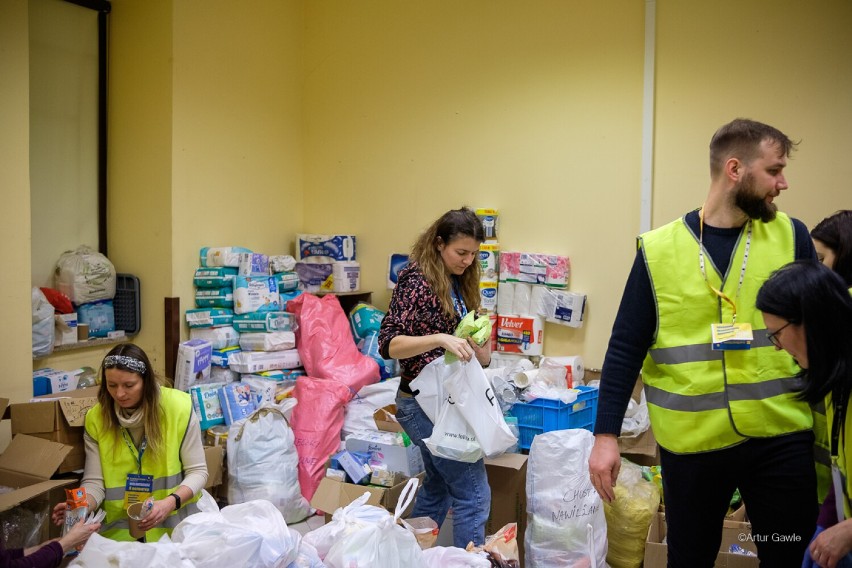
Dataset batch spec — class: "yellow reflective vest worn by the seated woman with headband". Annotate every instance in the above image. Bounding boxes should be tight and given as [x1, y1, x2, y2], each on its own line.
[86, 387, 199, 542]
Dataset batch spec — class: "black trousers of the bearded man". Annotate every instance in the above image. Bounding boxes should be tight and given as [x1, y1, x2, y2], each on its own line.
[660, 431, 817, 568]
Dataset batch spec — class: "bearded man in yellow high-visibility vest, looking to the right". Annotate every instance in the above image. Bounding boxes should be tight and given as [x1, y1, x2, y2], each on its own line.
[589, 119, 817, 568]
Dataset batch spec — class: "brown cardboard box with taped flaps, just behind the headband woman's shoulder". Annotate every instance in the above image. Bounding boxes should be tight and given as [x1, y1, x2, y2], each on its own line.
[10, 386, 100, 477]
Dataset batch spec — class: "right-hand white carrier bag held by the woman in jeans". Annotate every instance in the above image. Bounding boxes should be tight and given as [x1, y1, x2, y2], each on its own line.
[444, 358, 518, 458]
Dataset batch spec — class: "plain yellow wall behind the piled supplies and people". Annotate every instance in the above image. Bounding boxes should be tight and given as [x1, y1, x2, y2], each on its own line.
[0, 0, 852, 452]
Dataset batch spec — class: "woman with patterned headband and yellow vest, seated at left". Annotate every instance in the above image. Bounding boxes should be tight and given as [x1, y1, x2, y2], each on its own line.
[53, 343, 207, 542]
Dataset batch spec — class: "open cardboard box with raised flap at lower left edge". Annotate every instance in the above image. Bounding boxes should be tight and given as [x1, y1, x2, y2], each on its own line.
[0, 426, 79, 546]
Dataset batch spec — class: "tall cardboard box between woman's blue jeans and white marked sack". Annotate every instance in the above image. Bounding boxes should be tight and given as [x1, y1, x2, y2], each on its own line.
[485, 454, 527, 566]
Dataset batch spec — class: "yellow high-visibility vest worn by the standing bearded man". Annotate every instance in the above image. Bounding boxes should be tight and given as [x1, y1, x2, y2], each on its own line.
[638, 213, 812, 453]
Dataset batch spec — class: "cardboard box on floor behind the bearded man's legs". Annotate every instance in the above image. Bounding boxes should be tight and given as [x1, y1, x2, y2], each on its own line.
[643, 513, 760, 568]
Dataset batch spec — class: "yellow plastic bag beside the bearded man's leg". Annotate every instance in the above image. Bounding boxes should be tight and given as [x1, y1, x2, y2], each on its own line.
[604, 458, 660, 568]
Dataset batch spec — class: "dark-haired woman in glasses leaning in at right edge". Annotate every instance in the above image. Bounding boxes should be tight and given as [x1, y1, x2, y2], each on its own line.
[757, 261, 852, 568]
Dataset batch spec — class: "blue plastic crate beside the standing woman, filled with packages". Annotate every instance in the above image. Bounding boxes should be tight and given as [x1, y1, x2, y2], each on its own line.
[511, 385, 598, 450]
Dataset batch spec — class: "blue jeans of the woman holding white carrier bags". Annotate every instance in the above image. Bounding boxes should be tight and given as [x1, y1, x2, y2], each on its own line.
[396, 396, 491, 548]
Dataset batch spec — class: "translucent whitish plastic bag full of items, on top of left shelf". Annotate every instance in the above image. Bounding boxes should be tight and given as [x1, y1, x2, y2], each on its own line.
[54, 245, 116, 306]
